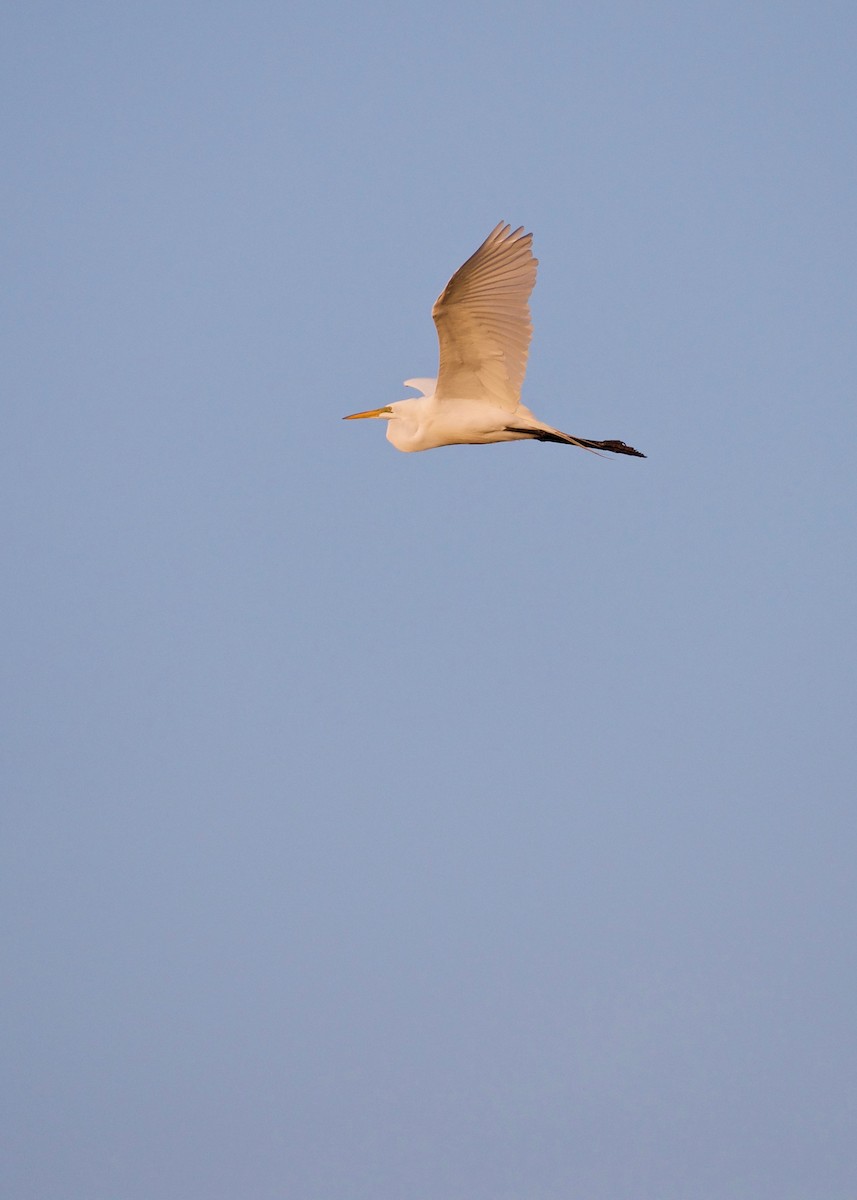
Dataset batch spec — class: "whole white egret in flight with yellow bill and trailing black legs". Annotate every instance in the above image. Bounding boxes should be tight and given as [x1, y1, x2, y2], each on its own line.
[343, 222, 646, 458]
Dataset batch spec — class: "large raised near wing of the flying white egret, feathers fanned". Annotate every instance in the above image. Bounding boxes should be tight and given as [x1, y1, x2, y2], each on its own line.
[432, 222, 539, 412]
